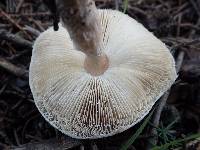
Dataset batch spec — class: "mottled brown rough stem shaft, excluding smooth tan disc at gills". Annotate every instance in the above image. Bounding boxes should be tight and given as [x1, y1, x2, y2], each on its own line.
[56, 0, 101, 56]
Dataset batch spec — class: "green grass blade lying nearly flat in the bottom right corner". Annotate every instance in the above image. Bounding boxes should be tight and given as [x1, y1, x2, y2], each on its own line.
[152, 133, 200, 150]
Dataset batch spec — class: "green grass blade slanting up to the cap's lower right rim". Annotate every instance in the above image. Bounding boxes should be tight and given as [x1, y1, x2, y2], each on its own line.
[120, 109, 155, 150]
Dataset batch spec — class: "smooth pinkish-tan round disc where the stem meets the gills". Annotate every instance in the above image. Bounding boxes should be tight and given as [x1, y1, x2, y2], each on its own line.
[84, 54, 109, 76]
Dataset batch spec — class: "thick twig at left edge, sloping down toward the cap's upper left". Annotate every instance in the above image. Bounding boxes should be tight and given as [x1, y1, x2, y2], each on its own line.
[0, 30, 32, 49]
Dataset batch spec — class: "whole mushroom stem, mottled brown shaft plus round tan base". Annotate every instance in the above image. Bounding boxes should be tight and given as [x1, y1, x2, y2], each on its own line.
[56, 0, 109, 76]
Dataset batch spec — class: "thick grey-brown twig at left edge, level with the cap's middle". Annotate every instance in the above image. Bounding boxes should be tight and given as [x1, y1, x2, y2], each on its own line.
[0, 58, 28, 78]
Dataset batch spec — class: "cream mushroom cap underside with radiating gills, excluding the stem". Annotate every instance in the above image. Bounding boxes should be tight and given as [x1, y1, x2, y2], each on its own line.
[29, 10, 177, 139]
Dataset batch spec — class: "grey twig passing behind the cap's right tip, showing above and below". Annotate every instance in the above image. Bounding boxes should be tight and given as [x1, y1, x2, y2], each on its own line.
[146, 51, 185, 150]
